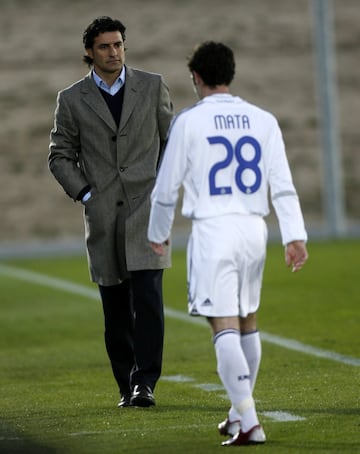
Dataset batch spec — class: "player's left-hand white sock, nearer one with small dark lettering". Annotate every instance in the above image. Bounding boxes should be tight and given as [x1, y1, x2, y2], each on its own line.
[214, 329, 259, 432]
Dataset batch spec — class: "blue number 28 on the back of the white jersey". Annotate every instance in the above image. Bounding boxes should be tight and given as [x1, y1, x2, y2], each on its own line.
[207, 136, 261, 195]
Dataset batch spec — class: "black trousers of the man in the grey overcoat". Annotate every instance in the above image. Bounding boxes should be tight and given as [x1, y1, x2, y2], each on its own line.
[99, 270, 164, 395]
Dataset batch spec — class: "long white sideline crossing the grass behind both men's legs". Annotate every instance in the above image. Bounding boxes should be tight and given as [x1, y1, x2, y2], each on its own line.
[0, 264, 360, 367]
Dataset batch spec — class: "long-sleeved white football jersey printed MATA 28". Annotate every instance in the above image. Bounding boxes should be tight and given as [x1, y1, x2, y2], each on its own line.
[148, 94, 307, 244]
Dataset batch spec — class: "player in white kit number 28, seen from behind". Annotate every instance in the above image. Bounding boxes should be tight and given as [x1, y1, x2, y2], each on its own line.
[148, 41, 308, 446]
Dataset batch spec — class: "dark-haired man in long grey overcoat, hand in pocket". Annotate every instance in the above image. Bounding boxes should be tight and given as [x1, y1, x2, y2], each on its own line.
[48, 16, 173, 408]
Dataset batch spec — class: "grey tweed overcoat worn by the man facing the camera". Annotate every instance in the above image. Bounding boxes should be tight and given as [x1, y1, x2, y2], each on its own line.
[49, 67, 173, 285]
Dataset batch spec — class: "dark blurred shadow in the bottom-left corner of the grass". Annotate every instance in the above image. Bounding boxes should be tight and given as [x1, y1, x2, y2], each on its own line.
[0, 420, 59, 454]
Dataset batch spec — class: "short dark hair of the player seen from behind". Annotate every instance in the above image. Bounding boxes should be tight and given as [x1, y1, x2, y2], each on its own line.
[188, 41, 235, 88]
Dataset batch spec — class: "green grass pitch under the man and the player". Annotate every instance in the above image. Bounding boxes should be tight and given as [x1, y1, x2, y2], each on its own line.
[0, 240, 360, 454]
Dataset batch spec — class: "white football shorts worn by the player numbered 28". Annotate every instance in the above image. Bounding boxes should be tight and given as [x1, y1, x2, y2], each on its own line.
[187, 214, 267, 317]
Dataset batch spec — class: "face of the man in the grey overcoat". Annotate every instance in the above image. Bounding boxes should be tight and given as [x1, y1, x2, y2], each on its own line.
[86, 31, 125, 77]
